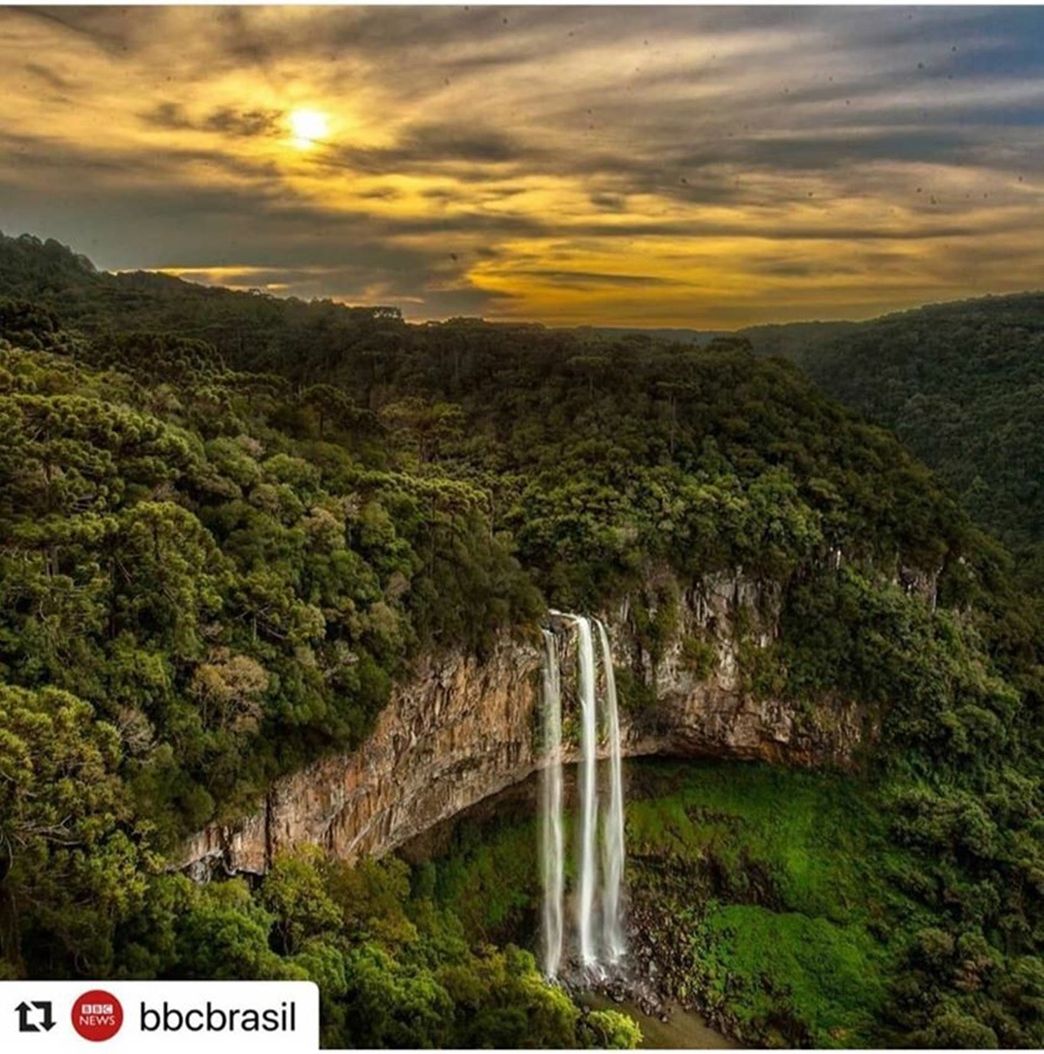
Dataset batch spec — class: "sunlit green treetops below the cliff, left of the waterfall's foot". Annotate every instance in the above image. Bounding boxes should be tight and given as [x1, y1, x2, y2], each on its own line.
[147, 851, 611, 1048]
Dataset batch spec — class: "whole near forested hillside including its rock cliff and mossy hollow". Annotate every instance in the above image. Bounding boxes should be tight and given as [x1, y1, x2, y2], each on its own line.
[0, 237, 1044, 1047]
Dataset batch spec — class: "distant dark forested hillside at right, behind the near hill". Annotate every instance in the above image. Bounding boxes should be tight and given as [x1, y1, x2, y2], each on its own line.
[746, 301, 1044, 589]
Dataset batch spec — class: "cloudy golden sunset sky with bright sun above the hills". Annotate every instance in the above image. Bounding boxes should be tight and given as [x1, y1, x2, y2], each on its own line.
[0, 5, 1044, 329]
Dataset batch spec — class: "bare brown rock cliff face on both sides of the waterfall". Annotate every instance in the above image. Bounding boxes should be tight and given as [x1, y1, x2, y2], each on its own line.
[179, 575, 874, 879]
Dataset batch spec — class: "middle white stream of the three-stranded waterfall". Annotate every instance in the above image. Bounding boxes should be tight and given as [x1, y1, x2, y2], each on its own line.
[576, 616, 598, 967]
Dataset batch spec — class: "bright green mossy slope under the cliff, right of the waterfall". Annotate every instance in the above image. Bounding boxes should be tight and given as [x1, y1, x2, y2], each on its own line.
[628, 763, 897, 1047]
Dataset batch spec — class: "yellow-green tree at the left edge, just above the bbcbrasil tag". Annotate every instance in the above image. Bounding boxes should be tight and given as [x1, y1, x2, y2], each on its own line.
[0, 684, 147, 975]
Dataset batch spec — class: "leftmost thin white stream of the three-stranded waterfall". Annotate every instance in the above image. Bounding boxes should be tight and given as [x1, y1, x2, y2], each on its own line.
[540, 629, 565, 978]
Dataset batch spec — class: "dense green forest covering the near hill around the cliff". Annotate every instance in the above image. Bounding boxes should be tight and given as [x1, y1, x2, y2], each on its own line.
[0, 237, 1044, 1047]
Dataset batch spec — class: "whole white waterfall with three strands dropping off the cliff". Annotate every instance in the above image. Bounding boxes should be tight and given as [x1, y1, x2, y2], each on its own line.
[540, 611, 626, 978]
